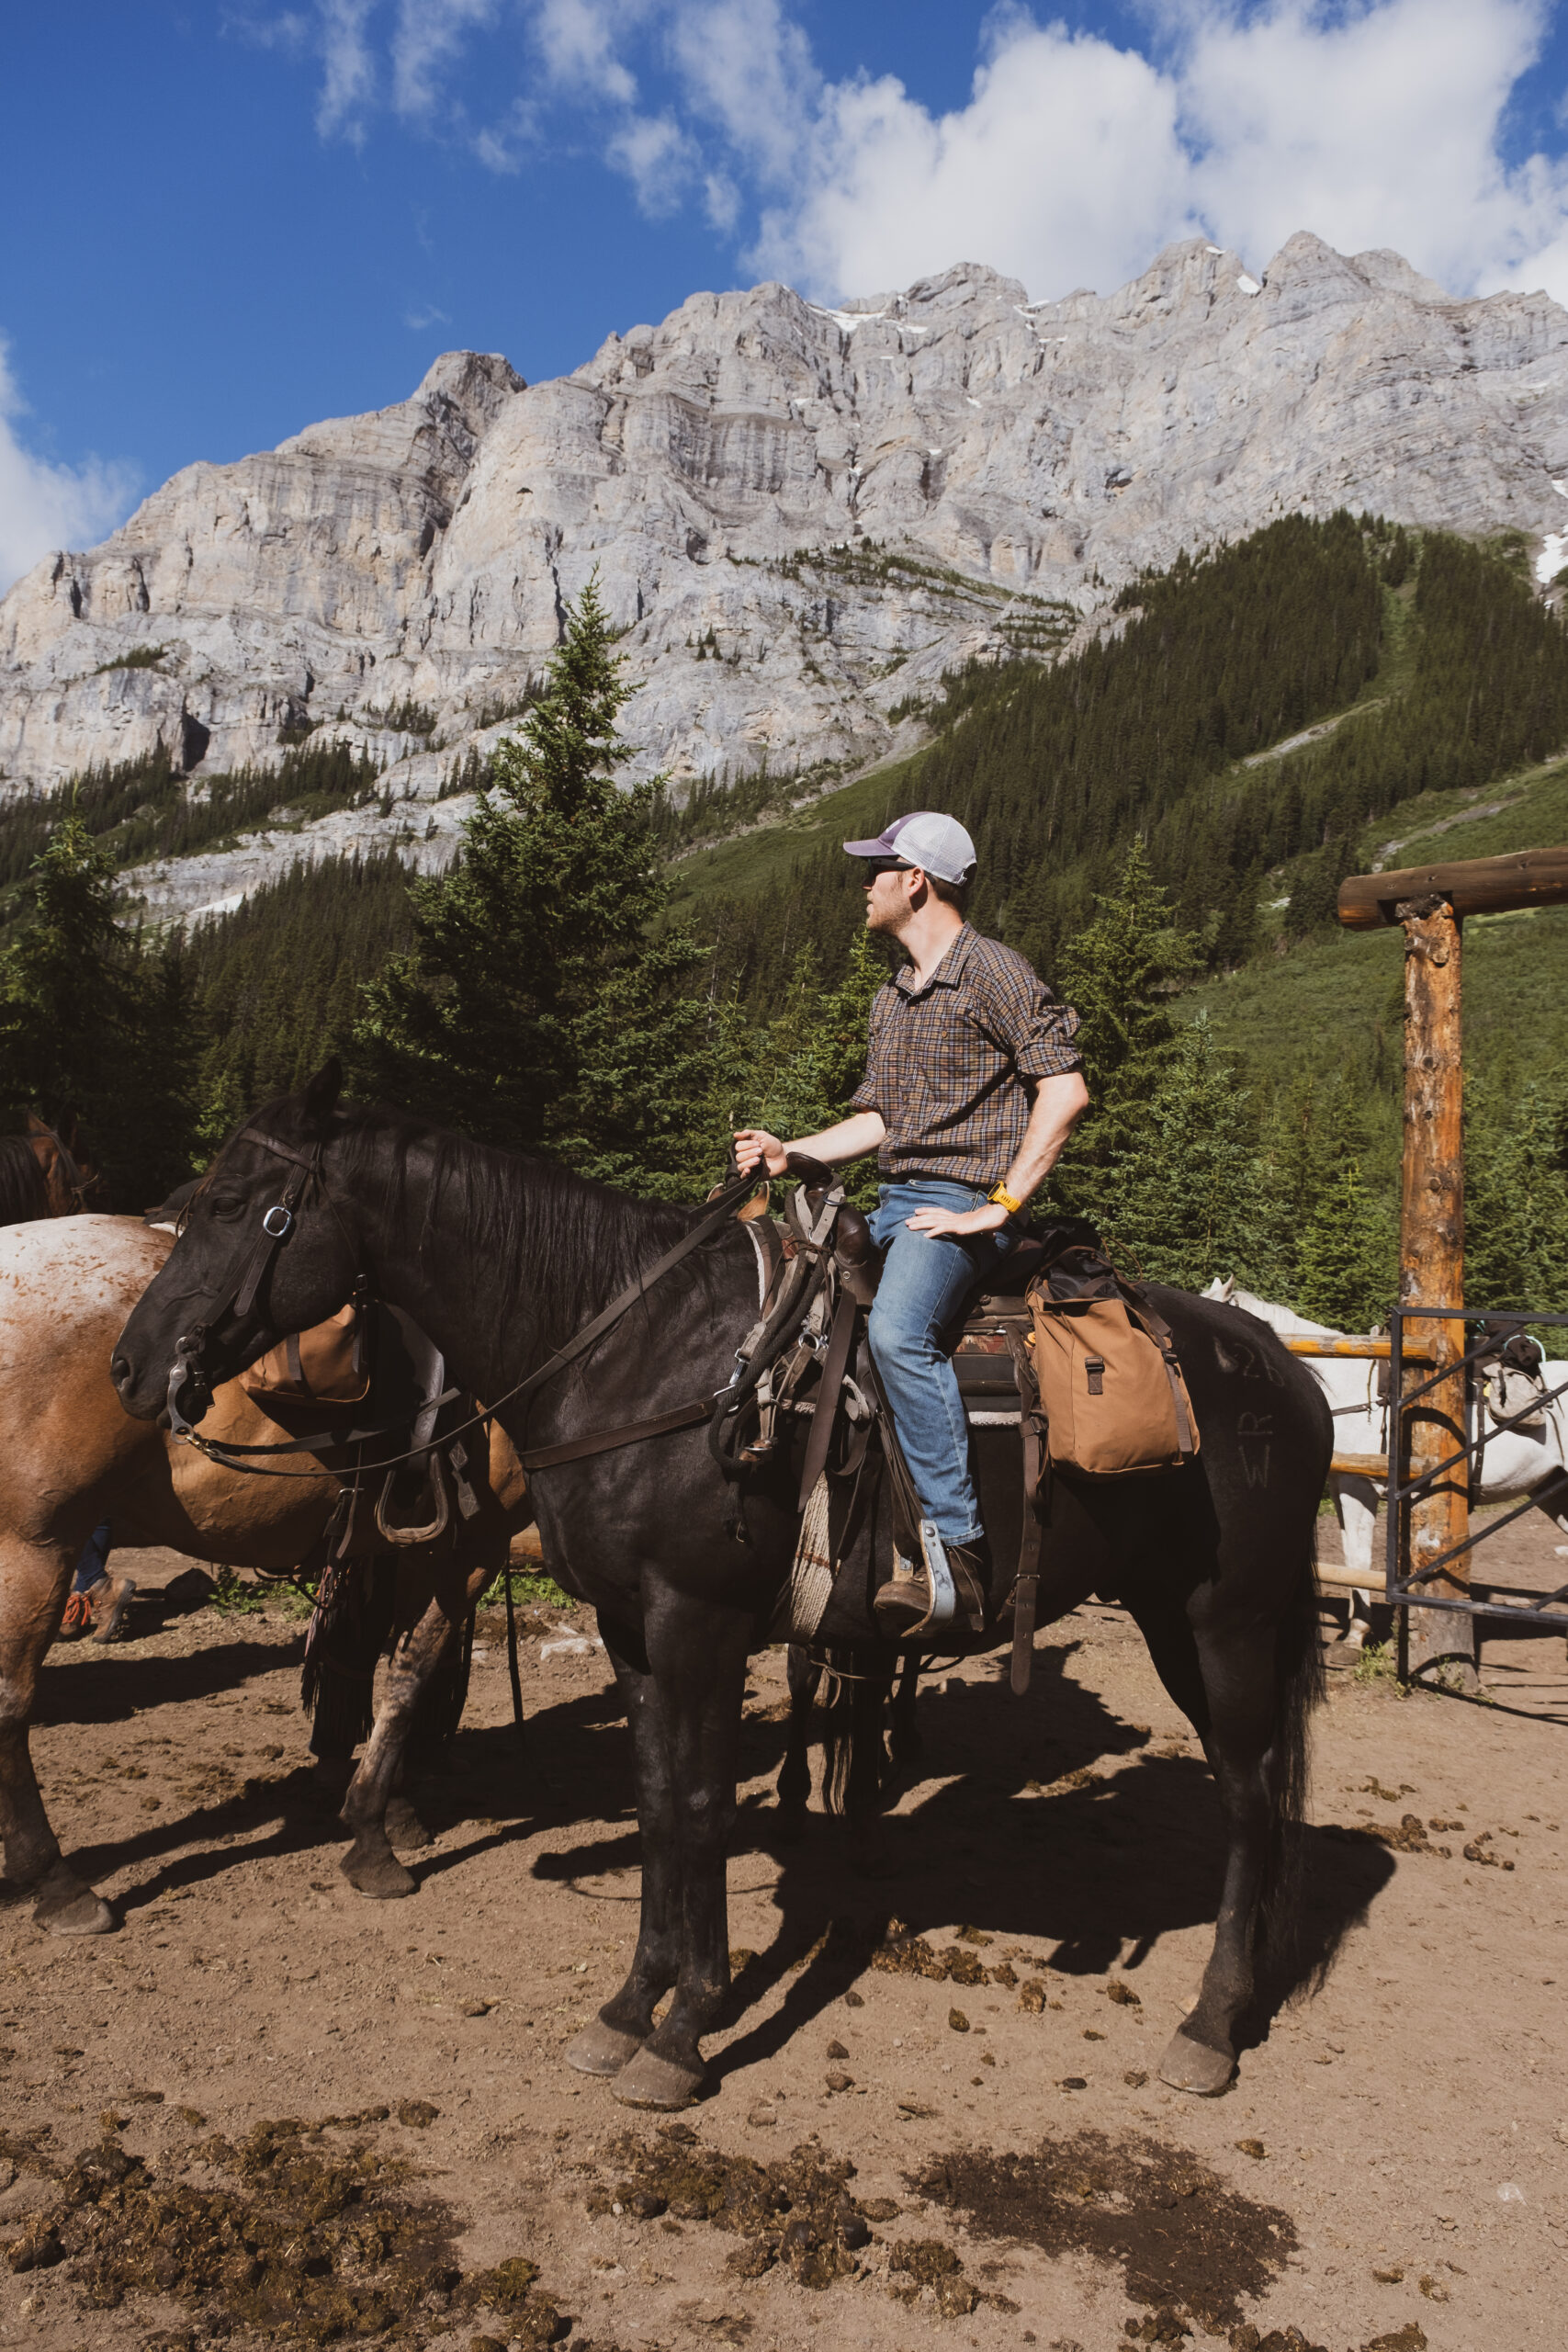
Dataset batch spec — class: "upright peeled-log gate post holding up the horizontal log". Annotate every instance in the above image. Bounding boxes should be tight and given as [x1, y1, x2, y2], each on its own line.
[1389, 891, 1476, 1689]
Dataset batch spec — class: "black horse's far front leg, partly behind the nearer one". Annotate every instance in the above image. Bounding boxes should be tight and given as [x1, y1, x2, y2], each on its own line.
[567, 1613, 682, 2075]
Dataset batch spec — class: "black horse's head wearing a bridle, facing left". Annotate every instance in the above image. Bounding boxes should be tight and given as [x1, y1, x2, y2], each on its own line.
[110, 1056, 362, 1430]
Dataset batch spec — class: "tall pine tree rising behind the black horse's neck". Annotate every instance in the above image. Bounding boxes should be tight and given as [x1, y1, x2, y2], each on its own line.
[353, 581, 705, 1194]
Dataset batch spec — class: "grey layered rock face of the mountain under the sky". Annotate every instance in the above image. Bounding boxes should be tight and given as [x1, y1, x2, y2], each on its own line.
[0, 235, 1568, 899]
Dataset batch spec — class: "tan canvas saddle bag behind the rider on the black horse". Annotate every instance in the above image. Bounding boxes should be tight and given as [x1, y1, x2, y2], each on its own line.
[1027, 1247, 1199, 1477]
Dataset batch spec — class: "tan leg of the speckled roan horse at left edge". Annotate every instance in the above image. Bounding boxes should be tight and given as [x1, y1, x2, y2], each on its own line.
[0, 1541, 118, 1936]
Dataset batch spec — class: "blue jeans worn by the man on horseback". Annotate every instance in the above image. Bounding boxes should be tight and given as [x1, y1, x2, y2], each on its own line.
[870, 1176, 1013, 1543]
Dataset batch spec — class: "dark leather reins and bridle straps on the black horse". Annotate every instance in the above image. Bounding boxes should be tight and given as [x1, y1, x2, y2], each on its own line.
[169, 1134, 757, 1477]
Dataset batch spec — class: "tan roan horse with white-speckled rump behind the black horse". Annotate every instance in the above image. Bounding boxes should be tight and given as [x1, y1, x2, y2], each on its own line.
[0, 1216, 529, 1936]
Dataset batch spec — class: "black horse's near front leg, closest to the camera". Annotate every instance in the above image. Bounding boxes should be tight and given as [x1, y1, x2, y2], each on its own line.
[616, 1588, 755, 2108]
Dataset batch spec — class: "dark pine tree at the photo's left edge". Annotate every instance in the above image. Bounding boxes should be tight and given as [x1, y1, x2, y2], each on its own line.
[0, 814, 200, 1209]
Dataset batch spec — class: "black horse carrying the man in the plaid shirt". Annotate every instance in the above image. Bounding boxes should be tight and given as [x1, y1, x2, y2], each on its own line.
[113, 1063, 1331, 2108]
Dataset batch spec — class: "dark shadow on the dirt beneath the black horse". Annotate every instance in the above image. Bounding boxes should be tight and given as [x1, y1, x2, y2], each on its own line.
[712, 1644, 1394, 2082]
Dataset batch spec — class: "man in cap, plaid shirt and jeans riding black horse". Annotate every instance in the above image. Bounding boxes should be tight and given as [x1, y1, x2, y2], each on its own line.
[736, 809, 1089, 1637]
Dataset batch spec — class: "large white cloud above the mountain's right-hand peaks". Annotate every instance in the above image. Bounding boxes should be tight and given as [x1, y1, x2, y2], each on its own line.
[280, 0, 1568, 299]
